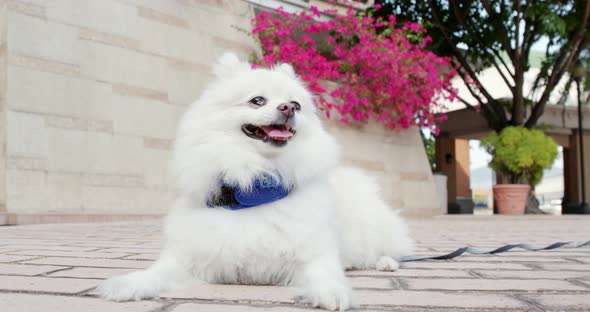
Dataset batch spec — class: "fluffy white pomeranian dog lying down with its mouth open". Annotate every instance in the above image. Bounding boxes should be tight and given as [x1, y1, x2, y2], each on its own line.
[98, 53, 413, 310]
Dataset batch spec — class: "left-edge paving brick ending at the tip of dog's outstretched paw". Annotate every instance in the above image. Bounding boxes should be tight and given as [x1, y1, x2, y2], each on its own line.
[0, 275, 96, 294]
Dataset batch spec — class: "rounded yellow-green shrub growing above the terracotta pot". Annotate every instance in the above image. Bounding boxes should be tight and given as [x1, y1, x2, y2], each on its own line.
[481, 127, 557, 187]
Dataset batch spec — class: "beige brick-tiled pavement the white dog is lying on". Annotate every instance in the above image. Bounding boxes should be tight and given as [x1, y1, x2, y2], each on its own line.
[0, 216, 590, 312]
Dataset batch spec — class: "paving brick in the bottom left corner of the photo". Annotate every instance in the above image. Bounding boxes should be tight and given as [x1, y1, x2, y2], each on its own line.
[0, 293, 162, 312]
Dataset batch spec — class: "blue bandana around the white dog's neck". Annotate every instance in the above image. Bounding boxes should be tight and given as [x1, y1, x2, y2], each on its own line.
[207, 175, 290, 210]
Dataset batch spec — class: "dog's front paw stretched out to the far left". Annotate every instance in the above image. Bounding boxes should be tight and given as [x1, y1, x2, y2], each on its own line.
[96, 272, 159, 301]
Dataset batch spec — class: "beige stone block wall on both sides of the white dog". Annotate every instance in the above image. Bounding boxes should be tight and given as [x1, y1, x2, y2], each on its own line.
[0, 0, 442, 220]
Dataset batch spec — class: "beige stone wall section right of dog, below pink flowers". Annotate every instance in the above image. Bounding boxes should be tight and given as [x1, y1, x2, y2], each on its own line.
[327, 120, 446, 217]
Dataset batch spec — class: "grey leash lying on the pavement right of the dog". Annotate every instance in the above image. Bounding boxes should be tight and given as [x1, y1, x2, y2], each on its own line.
[400, 240, 590, 262]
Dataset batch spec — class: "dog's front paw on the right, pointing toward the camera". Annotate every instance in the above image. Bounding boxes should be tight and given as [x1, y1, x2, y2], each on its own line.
[296, 285, 352, 311]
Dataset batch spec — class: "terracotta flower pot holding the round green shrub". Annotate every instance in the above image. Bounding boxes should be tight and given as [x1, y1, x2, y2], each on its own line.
[494, 184, 530, 215]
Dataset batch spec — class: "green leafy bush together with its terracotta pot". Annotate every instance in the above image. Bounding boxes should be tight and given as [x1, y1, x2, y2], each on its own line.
[481, 127, 557, 214]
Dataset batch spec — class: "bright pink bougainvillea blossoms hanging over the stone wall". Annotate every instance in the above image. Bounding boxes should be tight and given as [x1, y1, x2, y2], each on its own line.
[252, 6, 457, 133]
